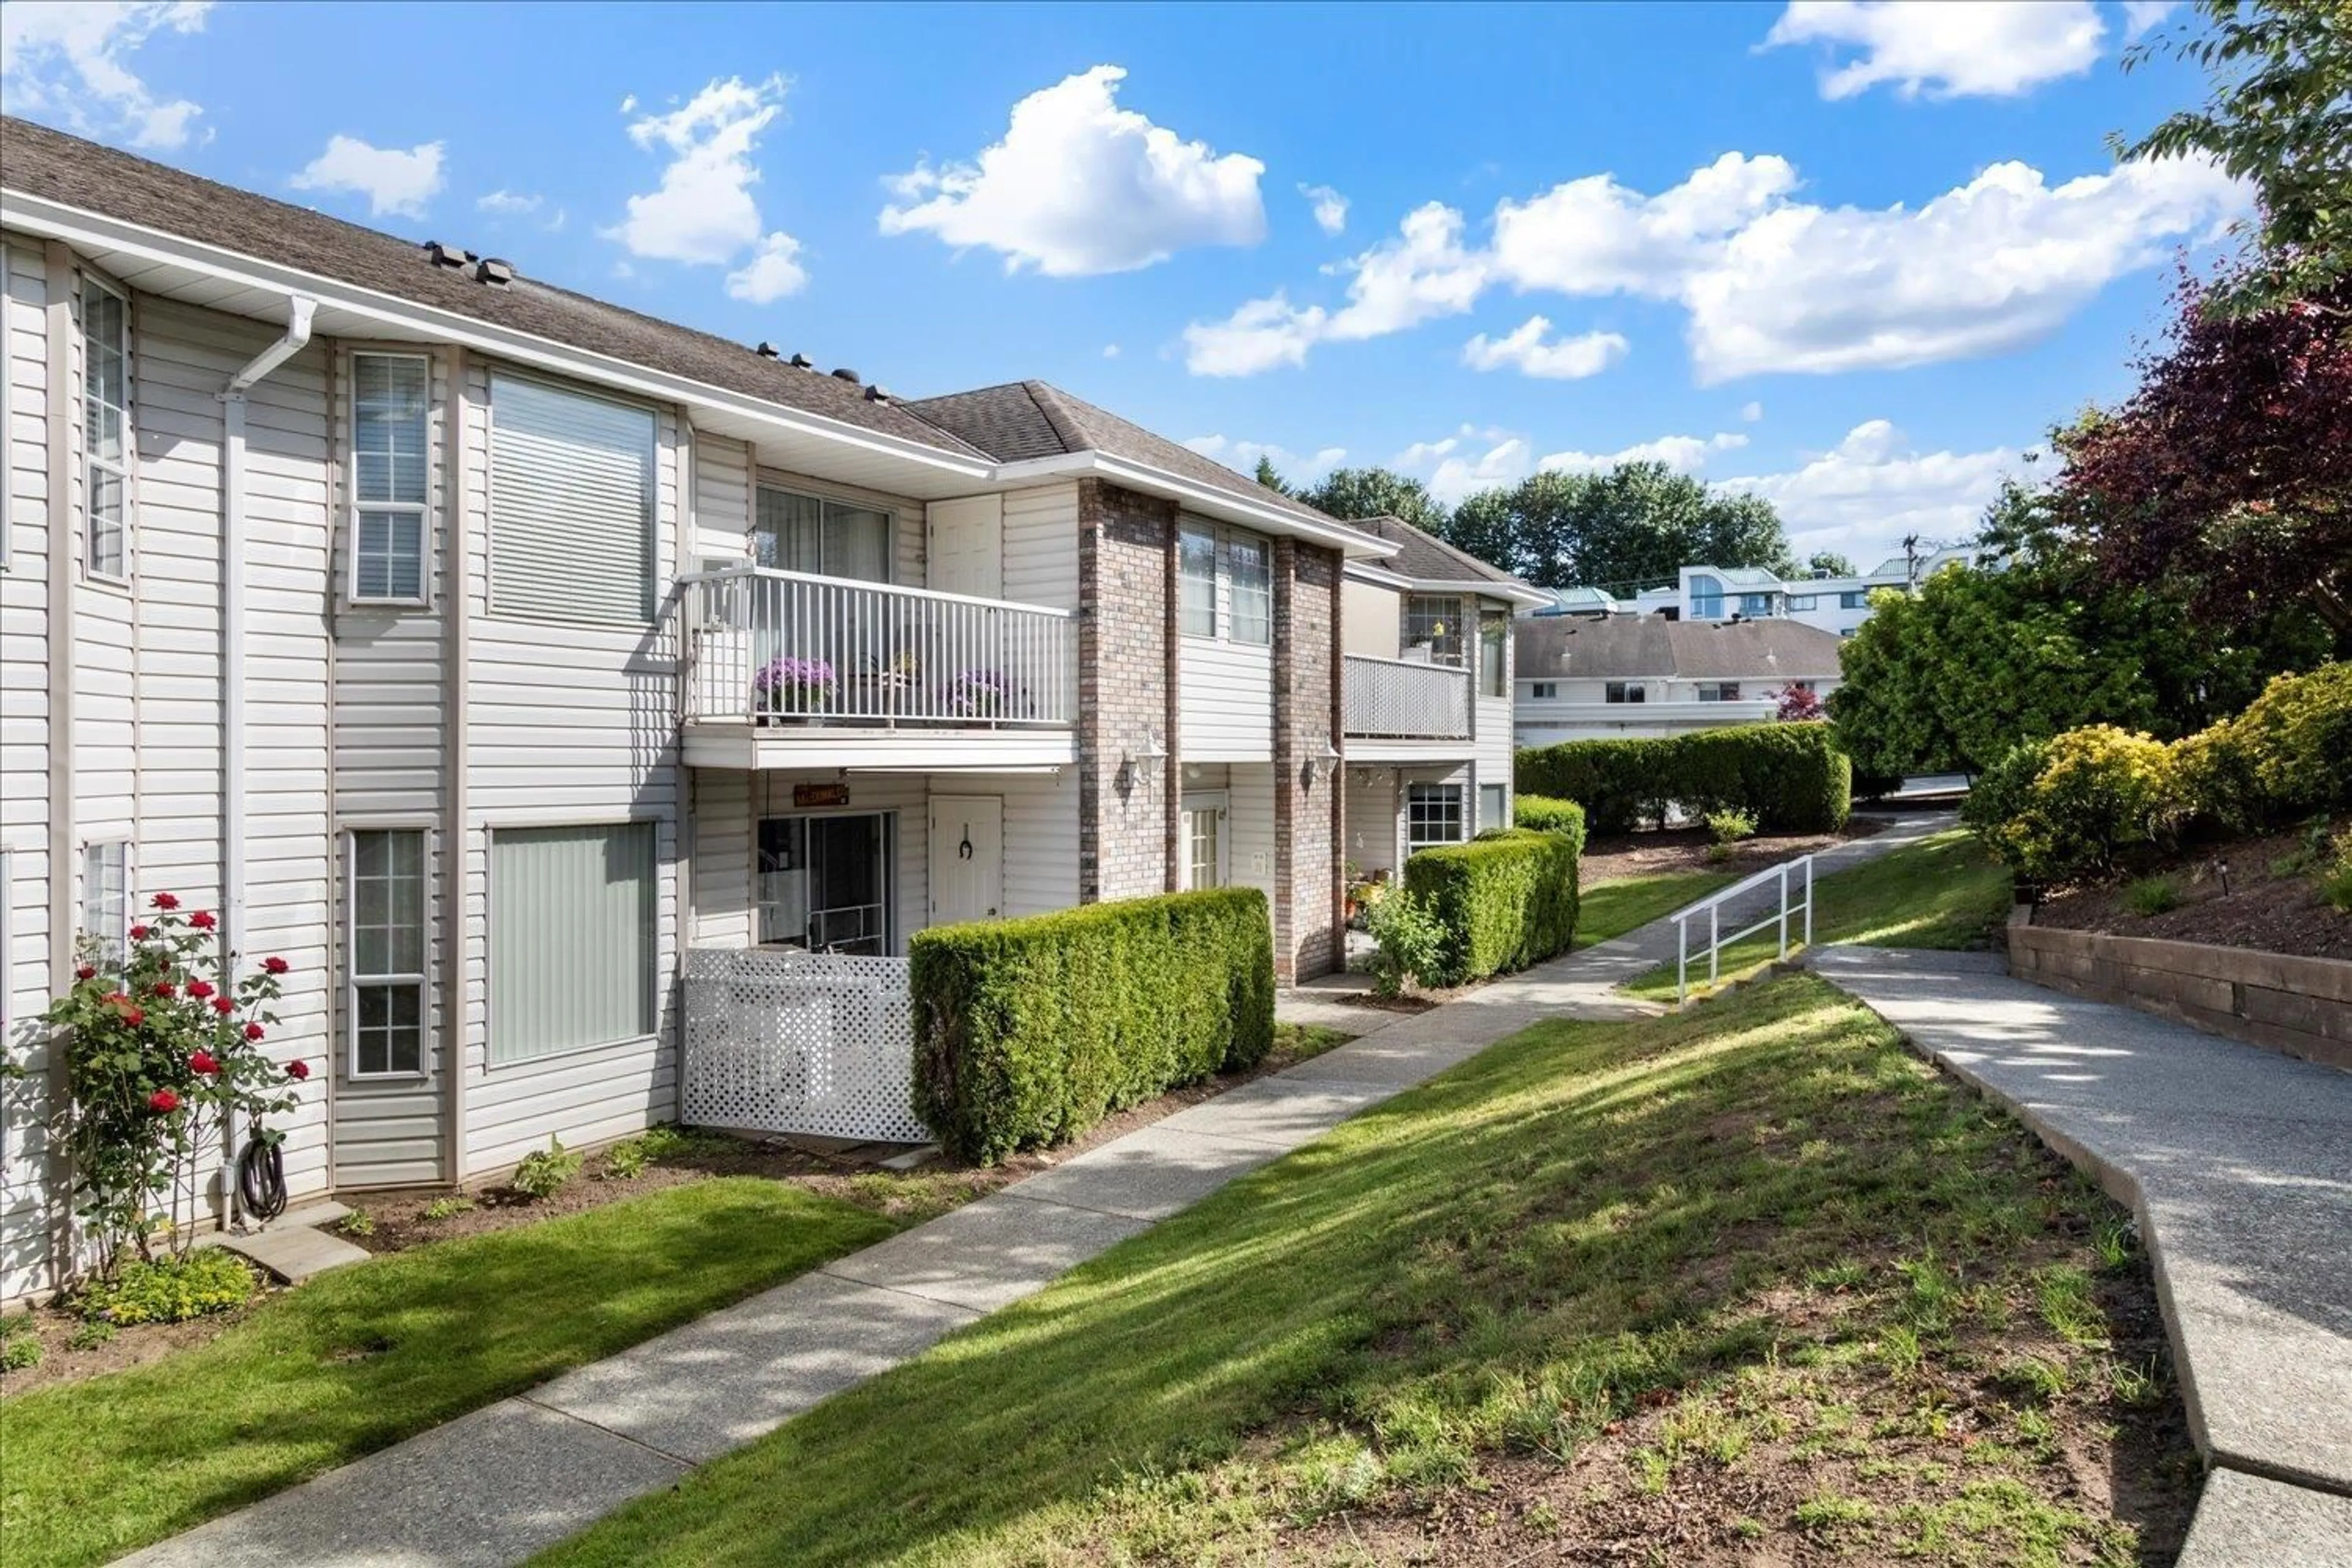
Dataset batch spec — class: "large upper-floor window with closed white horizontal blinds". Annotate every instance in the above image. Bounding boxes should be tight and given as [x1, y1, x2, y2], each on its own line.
[489, 376, 654, 623]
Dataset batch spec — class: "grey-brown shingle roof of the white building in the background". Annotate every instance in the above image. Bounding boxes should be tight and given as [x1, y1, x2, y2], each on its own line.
[1517, 616, 1839, 679]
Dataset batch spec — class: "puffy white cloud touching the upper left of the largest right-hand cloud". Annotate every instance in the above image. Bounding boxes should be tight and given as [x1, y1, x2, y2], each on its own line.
[1493, 153, 1797, 298]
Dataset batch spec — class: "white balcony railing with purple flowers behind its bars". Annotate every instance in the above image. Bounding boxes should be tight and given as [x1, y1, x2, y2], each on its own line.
[682, 567, 1077, 729]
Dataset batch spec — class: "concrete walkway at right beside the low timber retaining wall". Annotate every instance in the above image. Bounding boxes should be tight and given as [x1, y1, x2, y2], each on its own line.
[1809, 948, 2352, 1568]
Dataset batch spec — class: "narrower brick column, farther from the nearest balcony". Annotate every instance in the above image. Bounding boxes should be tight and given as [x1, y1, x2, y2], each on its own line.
[1275, 538, 1345, 985]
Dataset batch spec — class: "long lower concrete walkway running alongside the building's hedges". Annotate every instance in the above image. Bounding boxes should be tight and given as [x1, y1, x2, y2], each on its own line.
[105, 816, 1950, 1568]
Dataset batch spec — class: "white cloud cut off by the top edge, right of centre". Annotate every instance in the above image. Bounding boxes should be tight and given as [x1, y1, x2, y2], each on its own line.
[1762, 0, 2108, 99]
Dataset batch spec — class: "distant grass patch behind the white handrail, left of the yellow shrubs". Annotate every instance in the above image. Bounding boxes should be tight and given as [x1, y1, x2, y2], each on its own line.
[1623, 830, 2011, 1001]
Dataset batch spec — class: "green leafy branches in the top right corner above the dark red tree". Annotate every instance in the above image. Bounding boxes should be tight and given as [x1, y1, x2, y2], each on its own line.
[2109, 0, 2352, 315]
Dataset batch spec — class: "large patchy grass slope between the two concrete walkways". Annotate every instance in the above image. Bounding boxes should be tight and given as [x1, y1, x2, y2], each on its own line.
[533, 976, 2192, 1566]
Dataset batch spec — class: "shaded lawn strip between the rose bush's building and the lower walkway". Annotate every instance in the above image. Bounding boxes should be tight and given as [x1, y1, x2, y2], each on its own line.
[0, 1178, 899, 1566]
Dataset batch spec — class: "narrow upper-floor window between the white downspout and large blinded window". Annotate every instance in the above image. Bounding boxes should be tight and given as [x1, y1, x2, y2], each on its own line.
[350, 355, 431, 604]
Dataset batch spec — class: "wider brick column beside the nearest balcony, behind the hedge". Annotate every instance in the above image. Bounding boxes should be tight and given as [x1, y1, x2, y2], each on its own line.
[1077, 480, 1178, 903]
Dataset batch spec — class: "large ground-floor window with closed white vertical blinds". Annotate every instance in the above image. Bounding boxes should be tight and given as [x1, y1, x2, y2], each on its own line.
[489, 823, 654, 1063]
